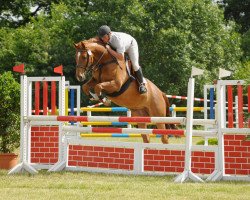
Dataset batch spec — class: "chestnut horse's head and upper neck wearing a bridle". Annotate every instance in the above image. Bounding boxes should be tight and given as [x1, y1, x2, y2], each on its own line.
[74, 38, 105, 81]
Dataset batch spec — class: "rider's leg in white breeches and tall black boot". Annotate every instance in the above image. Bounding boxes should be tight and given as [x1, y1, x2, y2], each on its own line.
[128, 40, 147, 94]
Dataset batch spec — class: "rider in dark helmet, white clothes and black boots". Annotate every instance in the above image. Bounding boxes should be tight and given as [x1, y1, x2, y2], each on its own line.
[98, 25, 147, 94]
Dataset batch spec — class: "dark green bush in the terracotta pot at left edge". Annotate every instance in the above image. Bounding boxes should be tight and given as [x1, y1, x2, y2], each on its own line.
[0, 72, 20, 153]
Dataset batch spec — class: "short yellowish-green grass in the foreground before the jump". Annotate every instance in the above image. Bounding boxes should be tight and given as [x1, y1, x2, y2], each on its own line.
[0, 171, 250, 200]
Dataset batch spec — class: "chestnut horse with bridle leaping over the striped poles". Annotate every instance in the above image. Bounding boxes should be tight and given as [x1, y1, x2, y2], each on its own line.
[75, 38, 173, 143]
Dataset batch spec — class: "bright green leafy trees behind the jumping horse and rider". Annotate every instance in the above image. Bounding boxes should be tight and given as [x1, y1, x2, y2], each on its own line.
[0, 0, 242, 103]
